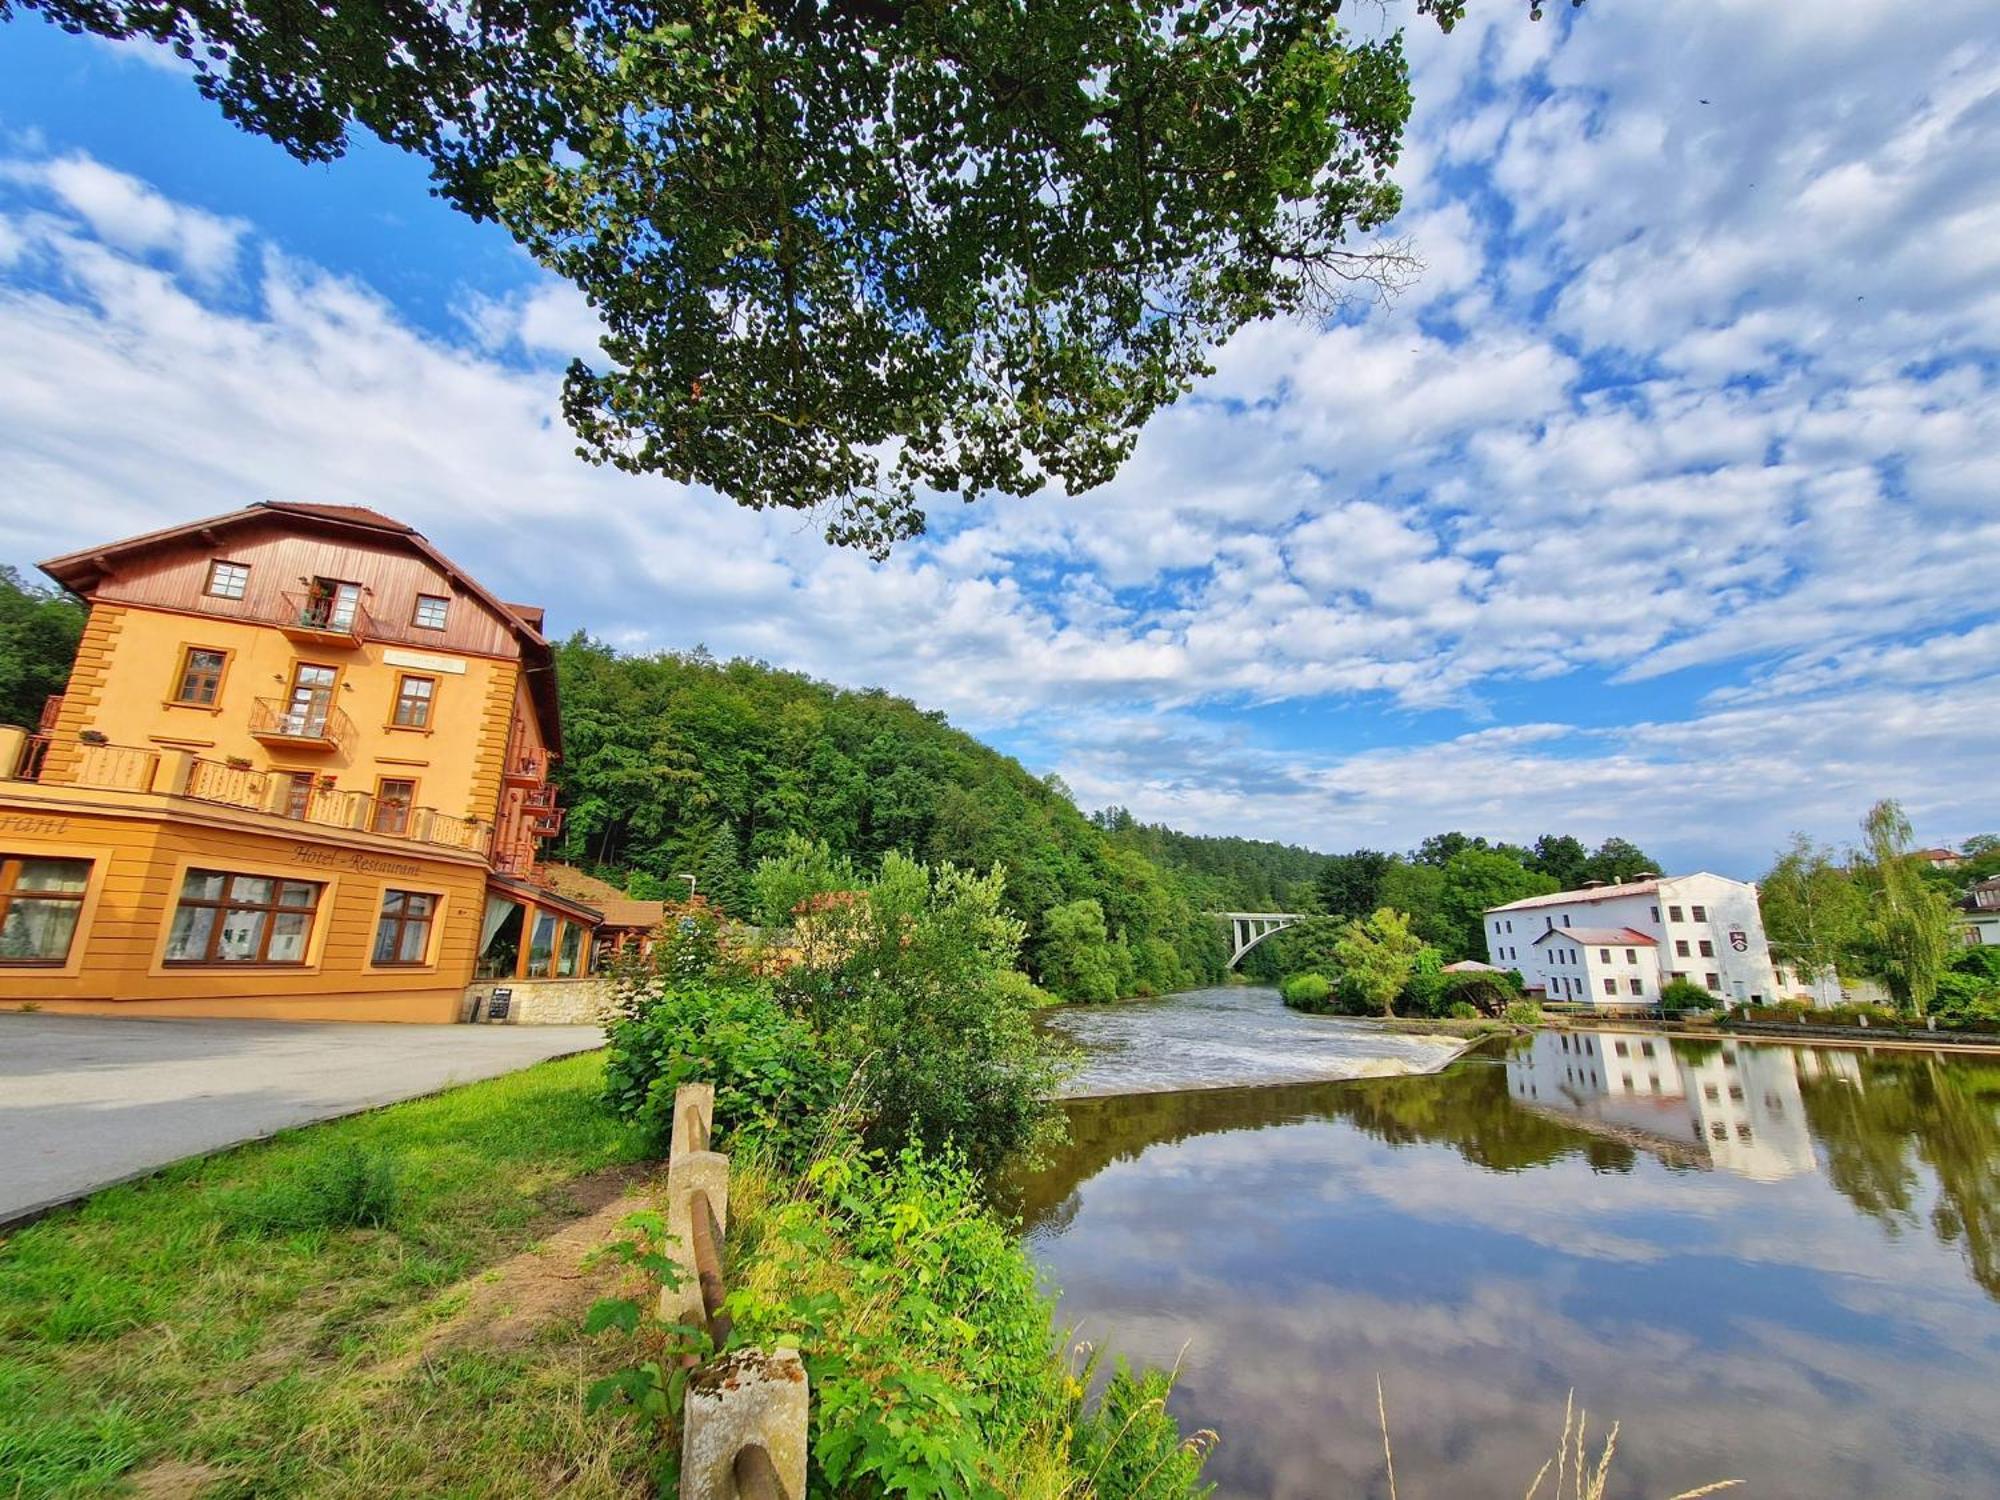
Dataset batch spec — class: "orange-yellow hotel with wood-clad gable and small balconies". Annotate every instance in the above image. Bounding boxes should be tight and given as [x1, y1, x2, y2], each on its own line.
[0, 502, 600, 1022]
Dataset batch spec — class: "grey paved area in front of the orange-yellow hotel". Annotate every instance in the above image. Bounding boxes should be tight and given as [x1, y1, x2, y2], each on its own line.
[0, 1012, 604, 1224]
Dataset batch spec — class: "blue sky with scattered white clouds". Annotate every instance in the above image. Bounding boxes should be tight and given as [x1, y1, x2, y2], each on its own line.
[0, 0, 2000, 874]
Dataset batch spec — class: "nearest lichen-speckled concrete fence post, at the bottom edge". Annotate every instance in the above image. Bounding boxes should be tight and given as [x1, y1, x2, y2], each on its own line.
[680, 1348, 808, 1500]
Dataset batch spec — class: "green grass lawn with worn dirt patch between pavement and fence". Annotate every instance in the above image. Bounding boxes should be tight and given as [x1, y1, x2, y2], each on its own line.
[0, 1054, 672, 1496]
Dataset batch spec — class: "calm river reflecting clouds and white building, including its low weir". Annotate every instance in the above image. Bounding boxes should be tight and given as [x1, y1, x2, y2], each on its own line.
[1016, 990, 2000, 1500]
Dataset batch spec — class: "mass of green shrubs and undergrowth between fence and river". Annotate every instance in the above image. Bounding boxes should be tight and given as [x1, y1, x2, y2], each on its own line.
[606, 856, 1206, 1500]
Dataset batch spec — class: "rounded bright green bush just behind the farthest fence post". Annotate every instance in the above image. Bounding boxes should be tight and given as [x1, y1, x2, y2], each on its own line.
[604, 978, 842, 1160]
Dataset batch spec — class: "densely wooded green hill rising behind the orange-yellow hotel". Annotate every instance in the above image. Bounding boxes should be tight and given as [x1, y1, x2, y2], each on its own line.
[556, 636, 1240, 1000]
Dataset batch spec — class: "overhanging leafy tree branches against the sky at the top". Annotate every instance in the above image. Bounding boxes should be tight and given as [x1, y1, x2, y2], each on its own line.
[0, 0, 1538, 554]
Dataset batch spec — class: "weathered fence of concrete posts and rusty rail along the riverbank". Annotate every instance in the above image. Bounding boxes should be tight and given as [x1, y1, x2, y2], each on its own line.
[660, 1084, 810, 1500]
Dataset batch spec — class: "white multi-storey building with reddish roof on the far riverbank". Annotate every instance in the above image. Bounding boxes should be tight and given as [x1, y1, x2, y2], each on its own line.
[1486, 874, 1784, 1008]
